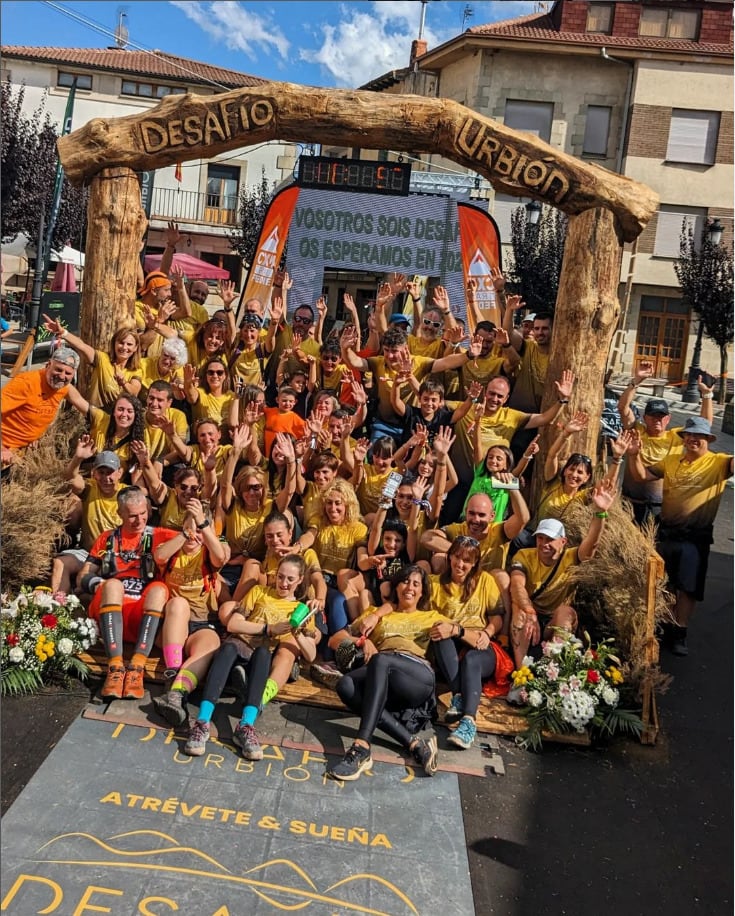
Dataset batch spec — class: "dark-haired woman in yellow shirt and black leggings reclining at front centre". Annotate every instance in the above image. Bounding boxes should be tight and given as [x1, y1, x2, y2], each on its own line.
[327, 566, 450, 782]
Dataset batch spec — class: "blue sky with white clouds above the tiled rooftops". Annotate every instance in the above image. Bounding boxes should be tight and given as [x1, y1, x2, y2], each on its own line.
[0, 0, 540, 88]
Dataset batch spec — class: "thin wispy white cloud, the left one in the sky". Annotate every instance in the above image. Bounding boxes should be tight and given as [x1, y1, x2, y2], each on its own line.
[170, 0, 290, 60]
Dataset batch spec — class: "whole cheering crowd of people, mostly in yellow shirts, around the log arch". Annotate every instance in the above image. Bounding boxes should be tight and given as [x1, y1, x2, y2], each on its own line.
[2, 224, 733, 780]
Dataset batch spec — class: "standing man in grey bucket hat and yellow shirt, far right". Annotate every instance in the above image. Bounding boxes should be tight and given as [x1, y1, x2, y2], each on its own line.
[628, 417, 733, 656]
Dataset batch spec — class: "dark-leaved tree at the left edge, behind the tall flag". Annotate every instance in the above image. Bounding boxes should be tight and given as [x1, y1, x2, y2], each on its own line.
[0, 82, 87, 249]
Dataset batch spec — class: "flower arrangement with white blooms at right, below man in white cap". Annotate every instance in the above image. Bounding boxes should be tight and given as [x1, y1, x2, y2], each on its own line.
[511, 631, 643, 750]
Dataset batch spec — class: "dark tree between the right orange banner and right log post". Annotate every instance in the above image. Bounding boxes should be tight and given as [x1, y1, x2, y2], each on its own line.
[506, 207, 567, 315]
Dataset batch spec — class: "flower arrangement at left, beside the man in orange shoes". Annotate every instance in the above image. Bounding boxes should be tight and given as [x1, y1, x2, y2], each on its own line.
[0, 586, 99, 694]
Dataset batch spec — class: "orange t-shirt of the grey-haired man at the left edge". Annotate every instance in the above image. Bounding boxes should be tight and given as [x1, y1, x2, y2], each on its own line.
[0, 368, 69, 448]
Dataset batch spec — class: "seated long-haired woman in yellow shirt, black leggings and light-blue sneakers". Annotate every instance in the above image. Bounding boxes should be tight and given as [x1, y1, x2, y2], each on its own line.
[430, 538, 510, 750]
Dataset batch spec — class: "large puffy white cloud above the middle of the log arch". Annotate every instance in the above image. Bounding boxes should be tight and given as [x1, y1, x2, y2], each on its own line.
[299, 0, 448, 86]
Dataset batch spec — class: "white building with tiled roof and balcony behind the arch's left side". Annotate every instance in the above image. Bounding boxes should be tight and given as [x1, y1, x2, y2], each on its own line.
[1, 47, 295, 286]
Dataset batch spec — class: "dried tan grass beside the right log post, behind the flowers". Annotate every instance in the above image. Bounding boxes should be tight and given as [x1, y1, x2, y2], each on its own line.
[564, 500, 674, 695]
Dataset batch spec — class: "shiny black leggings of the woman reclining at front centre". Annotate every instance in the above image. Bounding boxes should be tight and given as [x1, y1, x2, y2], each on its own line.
[337, 652, 434, 747]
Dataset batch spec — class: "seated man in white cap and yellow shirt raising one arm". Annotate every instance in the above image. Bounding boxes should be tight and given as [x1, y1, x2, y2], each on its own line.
[509, 479, 617, 668]
